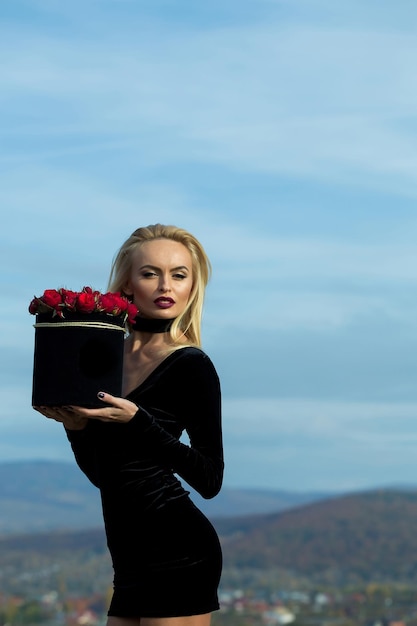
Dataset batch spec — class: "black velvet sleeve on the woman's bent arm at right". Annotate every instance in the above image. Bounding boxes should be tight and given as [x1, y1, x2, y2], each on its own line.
[128, 349, 224, 498]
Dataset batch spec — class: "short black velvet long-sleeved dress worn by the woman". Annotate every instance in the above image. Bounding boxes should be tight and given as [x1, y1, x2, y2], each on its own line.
[67, 347, 223, 617]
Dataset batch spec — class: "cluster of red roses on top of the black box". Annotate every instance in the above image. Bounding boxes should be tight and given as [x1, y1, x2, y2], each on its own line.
[29, 287, 138, 323]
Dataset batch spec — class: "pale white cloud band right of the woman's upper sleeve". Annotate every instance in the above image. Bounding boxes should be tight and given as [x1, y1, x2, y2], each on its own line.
[224, 397, 417, 442]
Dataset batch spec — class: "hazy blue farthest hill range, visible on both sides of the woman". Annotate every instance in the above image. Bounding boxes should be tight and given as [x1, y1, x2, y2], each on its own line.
[0, 461, 329, 535]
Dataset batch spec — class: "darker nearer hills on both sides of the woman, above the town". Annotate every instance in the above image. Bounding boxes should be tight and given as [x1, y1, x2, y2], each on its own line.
[0, 490, 417, 584]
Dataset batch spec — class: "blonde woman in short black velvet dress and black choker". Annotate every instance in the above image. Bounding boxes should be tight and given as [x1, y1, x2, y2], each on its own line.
[38, 224, 223, 626]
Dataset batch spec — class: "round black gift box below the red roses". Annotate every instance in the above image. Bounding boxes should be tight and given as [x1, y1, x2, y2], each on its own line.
[32, 313, 125, 407]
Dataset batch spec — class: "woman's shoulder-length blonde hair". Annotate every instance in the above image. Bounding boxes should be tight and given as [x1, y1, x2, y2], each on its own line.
[108, 224, 211, 346]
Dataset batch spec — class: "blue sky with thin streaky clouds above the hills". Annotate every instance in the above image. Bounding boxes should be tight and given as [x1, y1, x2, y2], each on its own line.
[0, 0, 417, 491]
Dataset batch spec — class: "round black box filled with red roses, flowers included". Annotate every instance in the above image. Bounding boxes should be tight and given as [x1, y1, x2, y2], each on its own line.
[29, 287, 138, 407]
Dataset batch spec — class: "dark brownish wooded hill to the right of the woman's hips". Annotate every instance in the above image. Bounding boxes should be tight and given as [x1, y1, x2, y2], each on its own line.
[216, 490, 417, 582]
